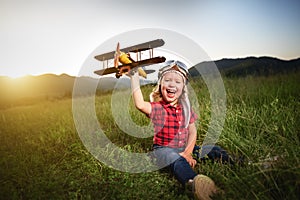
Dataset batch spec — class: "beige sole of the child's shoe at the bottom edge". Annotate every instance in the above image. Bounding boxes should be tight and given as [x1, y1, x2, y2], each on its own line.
[193, 174, 217, 200]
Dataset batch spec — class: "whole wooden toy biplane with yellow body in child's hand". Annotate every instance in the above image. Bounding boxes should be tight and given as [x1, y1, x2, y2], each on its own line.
[94, 39, 166, 78]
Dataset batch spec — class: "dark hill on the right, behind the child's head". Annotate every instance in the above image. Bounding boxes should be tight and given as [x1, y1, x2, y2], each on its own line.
[189, 57, 300, 77]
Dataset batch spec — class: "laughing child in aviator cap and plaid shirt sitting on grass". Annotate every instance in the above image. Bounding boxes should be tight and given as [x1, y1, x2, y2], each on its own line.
[129, 60, 216, 199]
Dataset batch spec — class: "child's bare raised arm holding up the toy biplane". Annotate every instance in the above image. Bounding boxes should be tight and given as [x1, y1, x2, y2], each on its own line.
[130, 73, 151, 115]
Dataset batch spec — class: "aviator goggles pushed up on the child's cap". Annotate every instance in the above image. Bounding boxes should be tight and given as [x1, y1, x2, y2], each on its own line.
[158, 60, 189, 80]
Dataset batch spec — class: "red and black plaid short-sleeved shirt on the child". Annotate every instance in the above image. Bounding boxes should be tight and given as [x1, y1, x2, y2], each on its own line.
[149, 101, 197, 148]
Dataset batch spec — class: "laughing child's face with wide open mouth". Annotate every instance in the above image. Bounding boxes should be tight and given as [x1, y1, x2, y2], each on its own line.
[161, 72, 184, 105]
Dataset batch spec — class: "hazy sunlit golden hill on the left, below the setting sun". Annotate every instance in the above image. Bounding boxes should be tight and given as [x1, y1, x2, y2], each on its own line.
[0, 74, 146, 108]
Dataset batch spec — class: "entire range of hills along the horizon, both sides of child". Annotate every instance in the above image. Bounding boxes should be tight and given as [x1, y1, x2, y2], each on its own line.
[0, 57, 300, 107]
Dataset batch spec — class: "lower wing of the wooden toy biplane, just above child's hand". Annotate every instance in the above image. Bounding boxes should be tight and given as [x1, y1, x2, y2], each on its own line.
[94, 56, 166, 76]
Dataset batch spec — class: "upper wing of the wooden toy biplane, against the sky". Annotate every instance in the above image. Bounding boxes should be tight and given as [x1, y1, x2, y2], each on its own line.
[95, 39, 165, 61]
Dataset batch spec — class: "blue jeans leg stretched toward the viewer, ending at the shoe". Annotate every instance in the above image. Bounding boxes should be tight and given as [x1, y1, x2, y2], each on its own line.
[153, 145, 197, 185]
